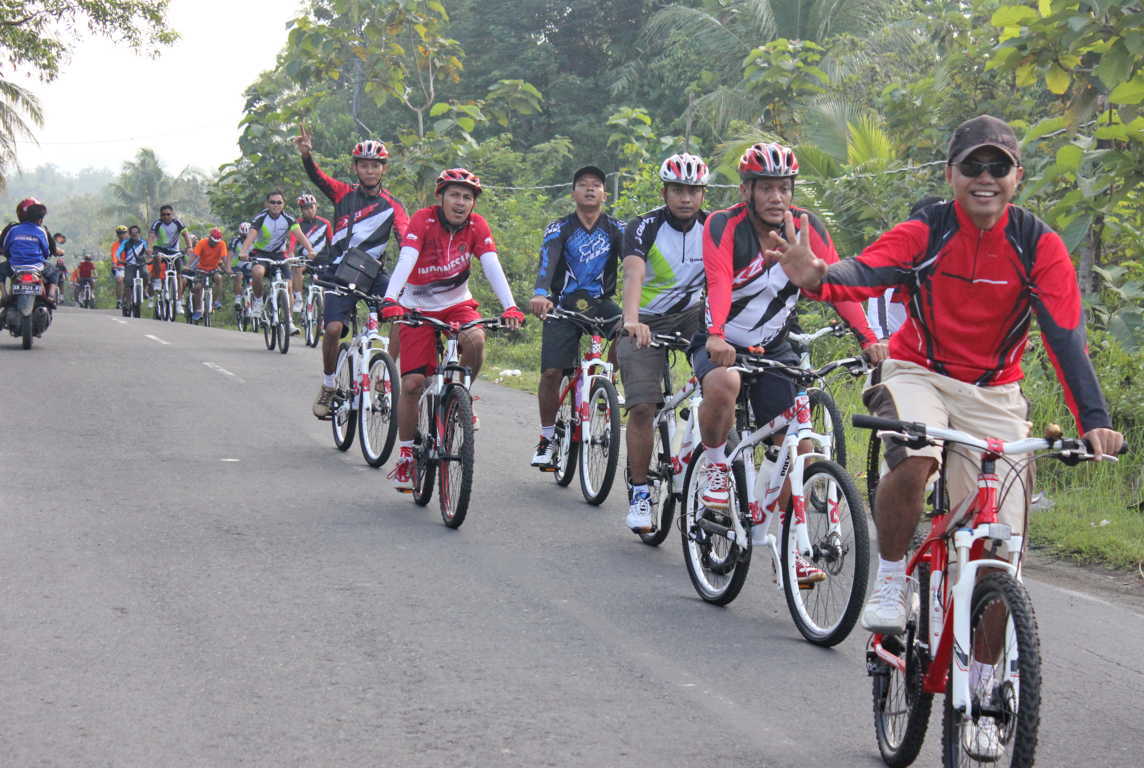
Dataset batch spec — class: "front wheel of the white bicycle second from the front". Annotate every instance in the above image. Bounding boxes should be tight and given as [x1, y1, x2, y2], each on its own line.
[782, 461, 869, 647]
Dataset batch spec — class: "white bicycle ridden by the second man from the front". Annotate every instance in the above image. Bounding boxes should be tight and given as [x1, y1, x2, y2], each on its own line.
[681, 355, 869, 647]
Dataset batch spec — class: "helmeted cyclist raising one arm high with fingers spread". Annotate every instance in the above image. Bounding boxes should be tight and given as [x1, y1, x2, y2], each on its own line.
[294, 125, 410, 419]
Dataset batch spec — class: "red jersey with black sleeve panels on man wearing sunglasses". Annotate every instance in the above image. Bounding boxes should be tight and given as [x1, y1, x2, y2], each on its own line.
[807, 203, 1111, 433]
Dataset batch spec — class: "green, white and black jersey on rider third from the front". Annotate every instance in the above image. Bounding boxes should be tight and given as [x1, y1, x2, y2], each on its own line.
[623, 205, 707, 315]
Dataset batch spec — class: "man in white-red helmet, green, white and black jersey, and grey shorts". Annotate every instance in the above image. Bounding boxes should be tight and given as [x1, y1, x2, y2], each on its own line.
[619, 155, 710, 532]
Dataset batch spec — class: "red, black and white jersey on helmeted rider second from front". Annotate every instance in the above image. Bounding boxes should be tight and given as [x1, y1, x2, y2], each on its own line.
[704, 203, 877, 348]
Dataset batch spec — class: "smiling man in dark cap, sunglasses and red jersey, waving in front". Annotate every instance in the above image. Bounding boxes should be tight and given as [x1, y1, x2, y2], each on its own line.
[771, 114, 1123, 677]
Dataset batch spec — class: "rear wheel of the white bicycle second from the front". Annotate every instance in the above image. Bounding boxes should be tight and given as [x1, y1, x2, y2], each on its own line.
[680, 445, 752, 605]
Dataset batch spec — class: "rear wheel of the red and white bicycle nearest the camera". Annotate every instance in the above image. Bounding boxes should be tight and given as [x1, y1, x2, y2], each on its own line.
[867, 563, 934, 768]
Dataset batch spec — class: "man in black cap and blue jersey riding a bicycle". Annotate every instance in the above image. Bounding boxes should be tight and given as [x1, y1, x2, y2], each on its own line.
[529, 165, 623, 469]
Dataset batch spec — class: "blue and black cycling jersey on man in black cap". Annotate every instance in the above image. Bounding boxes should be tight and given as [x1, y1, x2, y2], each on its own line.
[535, 213, 623, 299]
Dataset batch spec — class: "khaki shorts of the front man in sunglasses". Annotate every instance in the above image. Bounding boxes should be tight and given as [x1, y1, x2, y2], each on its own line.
[863, 359, 1032, 536]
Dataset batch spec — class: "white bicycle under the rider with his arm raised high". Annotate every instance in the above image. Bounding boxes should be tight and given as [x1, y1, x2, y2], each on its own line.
[315, 280, 400, 467]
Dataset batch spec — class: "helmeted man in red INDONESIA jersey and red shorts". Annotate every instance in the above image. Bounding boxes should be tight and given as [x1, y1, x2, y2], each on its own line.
[381, 168, 524, 491]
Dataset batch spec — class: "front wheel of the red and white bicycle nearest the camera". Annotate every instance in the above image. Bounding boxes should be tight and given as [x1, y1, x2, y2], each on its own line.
[942, 572, 1041, 768]
